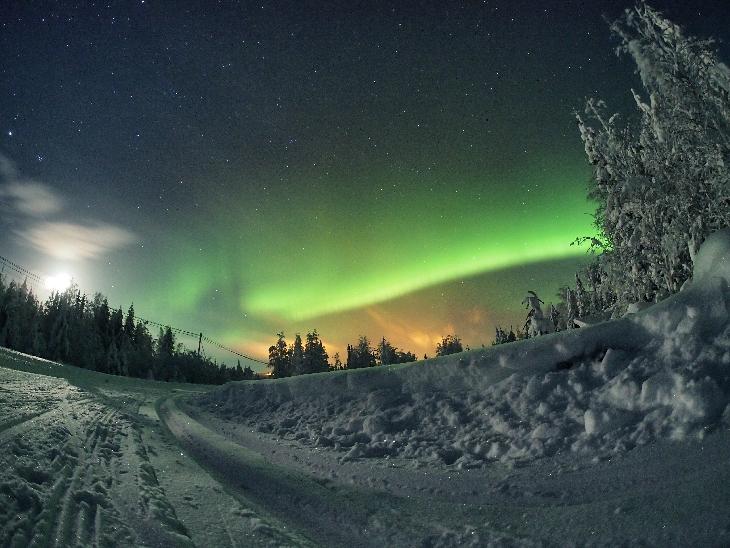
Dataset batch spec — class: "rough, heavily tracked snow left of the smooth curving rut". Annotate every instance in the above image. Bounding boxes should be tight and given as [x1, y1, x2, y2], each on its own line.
[0, 350, 298, 548]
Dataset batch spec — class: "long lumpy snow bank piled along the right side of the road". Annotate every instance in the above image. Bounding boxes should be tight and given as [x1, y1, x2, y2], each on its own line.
[191, 230, 730, 467]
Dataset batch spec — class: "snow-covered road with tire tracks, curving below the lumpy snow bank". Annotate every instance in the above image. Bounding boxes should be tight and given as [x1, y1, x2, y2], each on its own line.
[0, 351, 730, 547]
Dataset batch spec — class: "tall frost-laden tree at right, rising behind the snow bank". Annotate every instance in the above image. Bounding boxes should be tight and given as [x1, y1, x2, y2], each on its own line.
[577, 3, 730, 313]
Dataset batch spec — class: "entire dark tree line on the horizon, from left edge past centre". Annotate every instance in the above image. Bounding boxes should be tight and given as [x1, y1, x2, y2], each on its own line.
[0, 268, 463, 384]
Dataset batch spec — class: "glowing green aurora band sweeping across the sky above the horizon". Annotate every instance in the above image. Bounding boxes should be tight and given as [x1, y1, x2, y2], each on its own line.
[135, 159, 594, 358]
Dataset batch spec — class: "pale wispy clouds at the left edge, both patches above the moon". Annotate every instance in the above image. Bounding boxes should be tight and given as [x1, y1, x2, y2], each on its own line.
[0, 151, 135, 261]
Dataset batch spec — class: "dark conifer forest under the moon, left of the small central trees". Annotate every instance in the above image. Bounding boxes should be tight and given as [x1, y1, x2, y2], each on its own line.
[0, 276, 256, 384]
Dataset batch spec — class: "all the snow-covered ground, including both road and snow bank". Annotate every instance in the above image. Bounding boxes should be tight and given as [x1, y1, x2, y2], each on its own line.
[0, 231, 730, 546]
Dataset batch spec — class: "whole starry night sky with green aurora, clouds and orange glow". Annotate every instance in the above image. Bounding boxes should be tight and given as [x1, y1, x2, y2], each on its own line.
[0, 0, 730, 363]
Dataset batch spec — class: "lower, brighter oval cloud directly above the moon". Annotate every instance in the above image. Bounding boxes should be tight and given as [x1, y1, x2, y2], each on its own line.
[16, 222, 134, 261]
